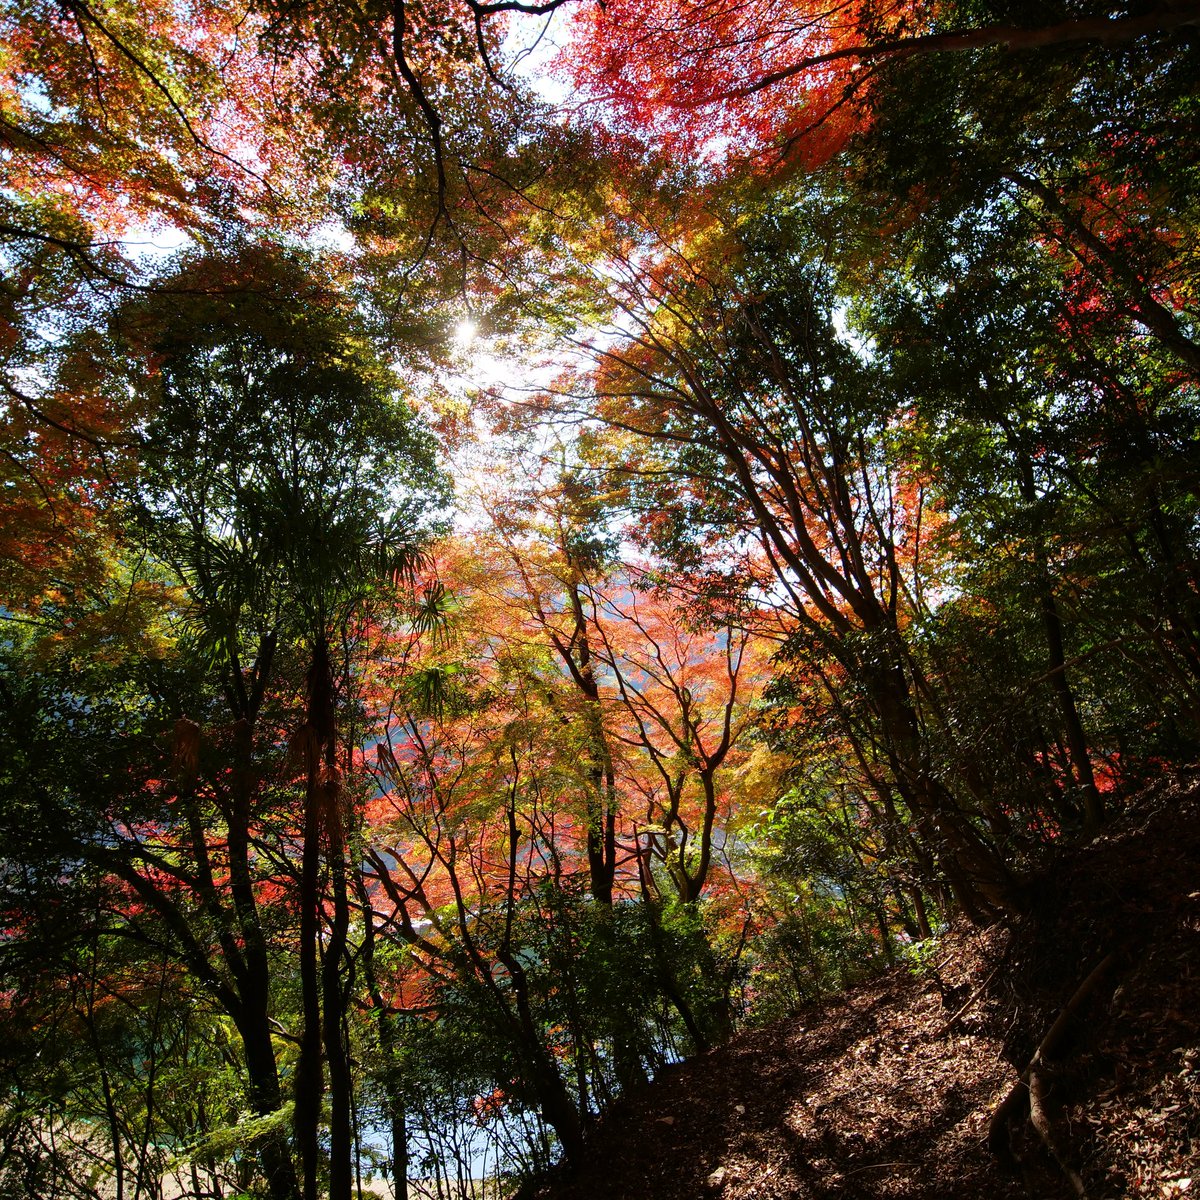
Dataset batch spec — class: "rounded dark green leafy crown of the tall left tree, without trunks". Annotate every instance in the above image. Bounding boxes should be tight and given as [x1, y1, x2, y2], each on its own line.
[115, 251, 446, 649]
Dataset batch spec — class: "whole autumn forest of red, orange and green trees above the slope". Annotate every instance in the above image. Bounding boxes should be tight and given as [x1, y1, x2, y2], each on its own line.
[0, 0, 1200, 1200]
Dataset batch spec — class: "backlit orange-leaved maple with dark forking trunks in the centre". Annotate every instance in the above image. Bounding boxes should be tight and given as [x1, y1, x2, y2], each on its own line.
[475, 466, 763, 1045]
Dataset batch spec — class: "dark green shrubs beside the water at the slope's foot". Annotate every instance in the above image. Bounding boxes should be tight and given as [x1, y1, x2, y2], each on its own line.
[379, 886, 732, 1178]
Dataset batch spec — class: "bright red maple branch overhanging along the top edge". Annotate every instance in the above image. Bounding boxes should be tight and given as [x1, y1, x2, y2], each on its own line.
[564, 0, 1200, 172]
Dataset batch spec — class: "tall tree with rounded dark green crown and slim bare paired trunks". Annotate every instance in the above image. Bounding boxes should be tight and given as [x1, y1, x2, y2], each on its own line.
[129, 250, 440, 1196]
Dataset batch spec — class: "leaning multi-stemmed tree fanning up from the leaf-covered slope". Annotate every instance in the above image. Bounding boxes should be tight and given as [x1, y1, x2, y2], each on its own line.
[544, 194, 1015, 916]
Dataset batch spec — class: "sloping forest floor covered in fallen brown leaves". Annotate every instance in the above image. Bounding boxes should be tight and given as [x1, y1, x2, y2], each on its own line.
[538, 769, 1200, 1200]
